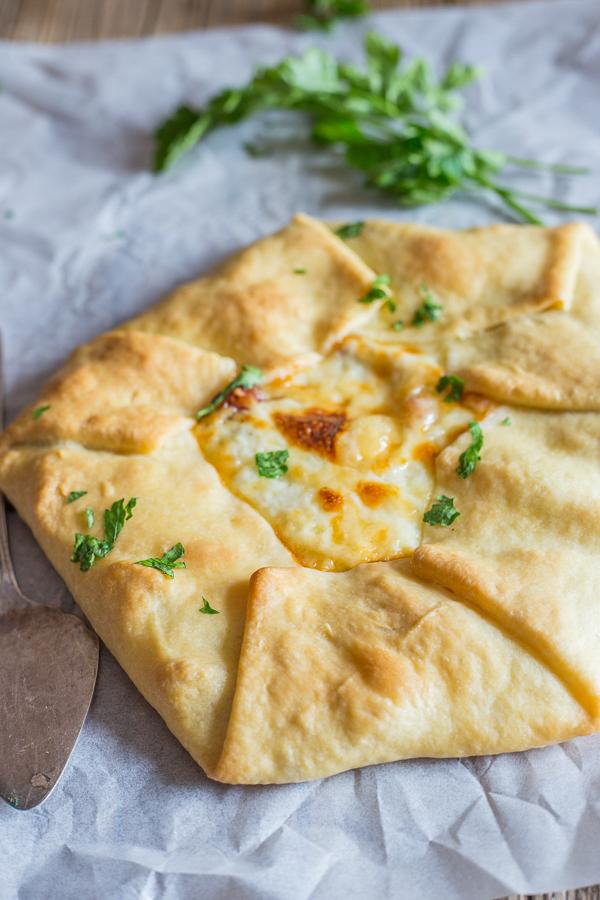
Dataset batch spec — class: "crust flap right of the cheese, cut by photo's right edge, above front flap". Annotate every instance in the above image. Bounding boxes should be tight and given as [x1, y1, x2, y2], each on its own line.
[412, 410, 600, 716]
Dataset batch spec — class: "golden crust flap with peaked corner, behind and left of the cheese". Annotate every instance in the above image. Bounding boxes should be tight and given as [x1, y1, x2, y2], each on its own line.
[128, 215, 375, 367]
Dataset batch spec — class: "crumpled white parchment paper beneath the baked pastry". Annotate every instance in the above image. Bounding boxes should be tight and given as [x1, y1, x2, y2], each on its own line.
[0, 0, 600, 900]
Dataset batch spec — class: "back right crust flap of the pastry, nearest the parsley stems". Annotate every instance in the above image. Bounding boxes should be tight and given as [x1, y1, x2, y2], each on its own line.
[348, 221, 593, 341]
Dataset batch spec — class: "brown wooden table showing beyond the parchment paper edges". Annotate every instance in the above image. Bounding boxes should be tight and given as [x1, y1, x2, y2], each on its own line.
[0, 0, 600, 900]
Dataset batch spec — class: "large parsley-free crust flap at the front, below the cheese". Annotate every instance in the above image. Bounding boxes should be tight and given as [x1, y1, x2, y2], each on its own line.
[215, 560, 600, 784]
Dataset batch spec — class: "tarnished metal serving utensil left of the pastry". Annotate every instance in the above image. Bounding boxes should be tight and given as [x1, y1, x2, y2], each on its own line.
[0, 340, 98, 809]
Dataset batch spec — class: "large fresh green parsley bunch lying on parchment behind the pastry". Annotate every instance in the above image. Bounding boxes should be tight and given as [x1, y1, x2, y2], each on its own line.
[154, 32, 598, 224]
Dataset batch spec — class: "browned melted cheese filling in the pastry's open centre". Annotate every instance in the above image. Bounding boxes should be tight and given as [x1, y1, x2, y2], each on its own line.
[195, 337, 488, 571]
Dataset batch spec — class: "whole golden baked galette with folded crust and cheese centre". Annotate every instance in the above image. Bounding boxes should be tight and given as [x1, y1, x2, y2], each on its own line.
[0, 216, 600, 784]
